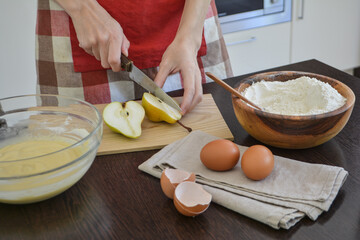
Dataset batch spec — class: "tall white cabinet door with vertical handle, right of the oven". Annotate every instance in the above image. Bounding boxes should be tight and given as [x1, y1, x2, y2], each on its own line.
[290, 0, 360, 70]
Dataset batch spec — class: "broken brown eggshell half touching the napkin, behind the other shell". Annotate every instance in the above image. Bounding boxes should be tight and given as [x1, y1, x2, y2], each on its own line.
[160, 168, 195, 199]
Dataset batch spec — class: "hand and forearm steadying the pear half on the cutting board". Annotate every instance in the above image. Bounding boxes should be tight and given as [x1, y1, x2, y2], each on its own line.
[154, 0, 210, 115]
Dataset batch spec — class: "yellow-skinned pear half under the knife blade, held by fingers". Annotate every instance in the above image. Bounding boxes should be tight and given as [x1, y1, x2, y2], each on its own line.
[142, 93, 182, 123]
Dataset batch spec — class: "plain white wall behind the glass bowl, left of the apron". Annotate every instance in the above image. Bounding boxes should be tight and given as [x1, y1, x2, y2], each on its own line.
[0, 0, 37, 99]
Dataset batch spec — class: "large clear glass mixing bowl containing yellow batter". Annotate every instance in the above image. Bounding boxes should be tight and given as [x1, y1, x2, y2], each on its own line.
[0, 95, 103, 204]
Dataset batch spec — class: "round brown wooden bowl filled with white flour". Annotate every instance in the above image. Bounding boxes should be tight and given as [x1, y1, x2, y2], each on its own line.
[232, 71, 355, 149]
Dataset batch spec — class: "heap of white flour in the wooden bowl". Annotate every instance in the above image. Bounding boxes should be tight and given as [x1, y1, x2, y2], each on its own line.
[241, 77, 346, 115]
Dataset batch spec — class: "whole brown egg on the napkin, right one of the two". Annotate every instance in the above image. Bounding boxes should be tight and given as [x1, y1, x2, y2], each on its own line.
[241, 145, 274, 180]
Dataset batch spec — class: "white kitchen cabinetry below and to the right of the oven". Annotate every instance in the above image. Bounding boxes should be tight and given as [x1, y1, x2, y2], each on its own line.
[224, 0, 360, 76]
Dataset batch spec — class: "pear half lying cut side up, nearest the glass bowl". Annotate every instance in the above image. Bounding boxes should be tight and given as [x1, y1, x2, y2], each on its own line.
[103, 101, 145, 138]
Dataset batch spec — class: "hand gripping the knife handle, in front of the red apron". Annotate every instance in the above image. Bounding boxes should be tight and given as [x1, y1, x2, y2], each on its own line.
[56, 0, 130, 72]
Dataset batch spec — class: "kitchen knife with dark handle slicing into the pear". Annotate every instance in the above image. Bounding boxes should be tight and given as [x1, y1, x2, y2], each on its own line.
[121, 54, 181, 112]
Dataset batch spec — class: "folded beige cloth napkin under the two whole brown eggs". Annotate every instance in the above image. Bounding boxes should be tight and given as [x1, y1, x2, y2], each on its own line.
[139, 131, 348, 229]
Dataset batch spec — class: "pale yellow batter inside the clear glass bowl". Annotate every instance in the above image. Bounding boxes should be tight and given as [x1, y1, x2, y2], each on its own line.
[0, 137, 87, 203]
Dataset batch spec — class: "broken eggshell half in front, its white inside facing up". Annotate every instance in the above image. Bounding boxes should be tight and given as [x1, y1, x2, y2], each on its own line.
[174, 182, 212, 217]
